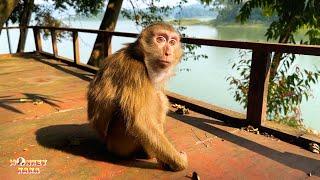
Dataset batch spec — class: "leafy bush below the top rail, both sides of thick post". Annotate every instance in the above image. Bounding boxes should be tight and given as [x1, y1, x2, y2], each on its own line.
[227, 50, 320, 124]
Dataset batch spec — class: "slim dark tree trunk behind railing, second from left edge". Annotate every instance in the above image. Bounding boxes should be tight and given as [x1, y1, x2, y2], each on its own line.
[17, 0, 34, 52]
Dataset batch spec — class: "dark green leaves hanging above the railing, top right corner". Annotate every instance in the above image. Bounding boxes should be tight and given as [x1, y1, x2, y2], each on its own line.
[235, 0, 320, 44]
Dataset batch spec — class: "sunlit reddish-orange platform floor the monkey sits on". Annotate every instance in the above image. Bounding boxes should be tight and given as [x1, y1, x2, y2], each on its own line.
[0, 55, 320, 179]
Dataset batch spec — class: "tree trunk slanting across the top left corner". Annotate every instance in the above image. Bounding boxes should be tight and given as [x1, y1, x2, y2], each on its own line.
[0, 0, 19, 35]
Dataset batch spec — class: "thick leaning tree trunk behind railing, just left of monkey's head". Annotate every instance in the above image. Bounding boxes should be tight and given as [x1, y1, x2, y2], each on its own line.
[88, 0, 123, 67]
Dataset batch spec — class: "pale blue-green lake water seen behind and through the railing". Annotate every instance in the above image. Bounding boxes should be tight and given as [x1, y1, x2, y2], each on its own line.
[0, 21, 320, 130]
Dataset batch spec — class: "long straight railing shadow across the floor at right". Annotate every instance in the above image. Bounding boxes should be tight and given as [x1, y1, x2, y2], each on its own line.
[168, 111, 320, 177]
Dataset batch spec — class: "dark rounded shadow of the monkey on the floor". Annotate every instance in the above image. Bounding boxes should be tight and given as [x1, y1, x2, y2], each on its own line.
[36, 124, 161, 169]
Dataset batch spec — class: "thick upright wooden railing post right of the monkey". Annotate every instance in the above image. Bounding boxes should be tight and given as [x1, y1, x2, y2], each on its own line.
[247, 49, 271, 127]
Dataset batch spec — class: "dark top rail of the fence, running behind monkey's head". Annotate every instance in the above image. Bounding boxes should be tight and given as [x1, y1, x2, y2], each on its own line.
[3, 26, 320, 56]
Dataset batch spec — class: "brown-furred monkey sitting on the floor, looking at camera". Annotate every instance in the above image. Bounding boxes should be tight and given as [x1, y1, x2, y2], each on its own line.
[87, 22, 188, 171]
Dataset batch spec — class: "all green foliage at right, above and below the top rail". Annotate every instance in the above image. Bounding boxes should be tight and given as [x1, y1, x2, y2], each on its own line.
[228, 0, 320, 126]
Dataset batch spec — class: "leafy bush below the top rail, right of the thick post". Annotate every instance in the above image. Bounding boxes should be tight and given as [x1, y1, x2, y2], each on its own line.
[268, 54, 320, 121]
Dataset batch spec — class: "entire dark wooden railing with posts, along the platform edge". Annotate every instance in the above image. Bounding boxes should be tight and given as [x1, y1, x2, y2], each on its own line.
[3, 26, 320, 147]
